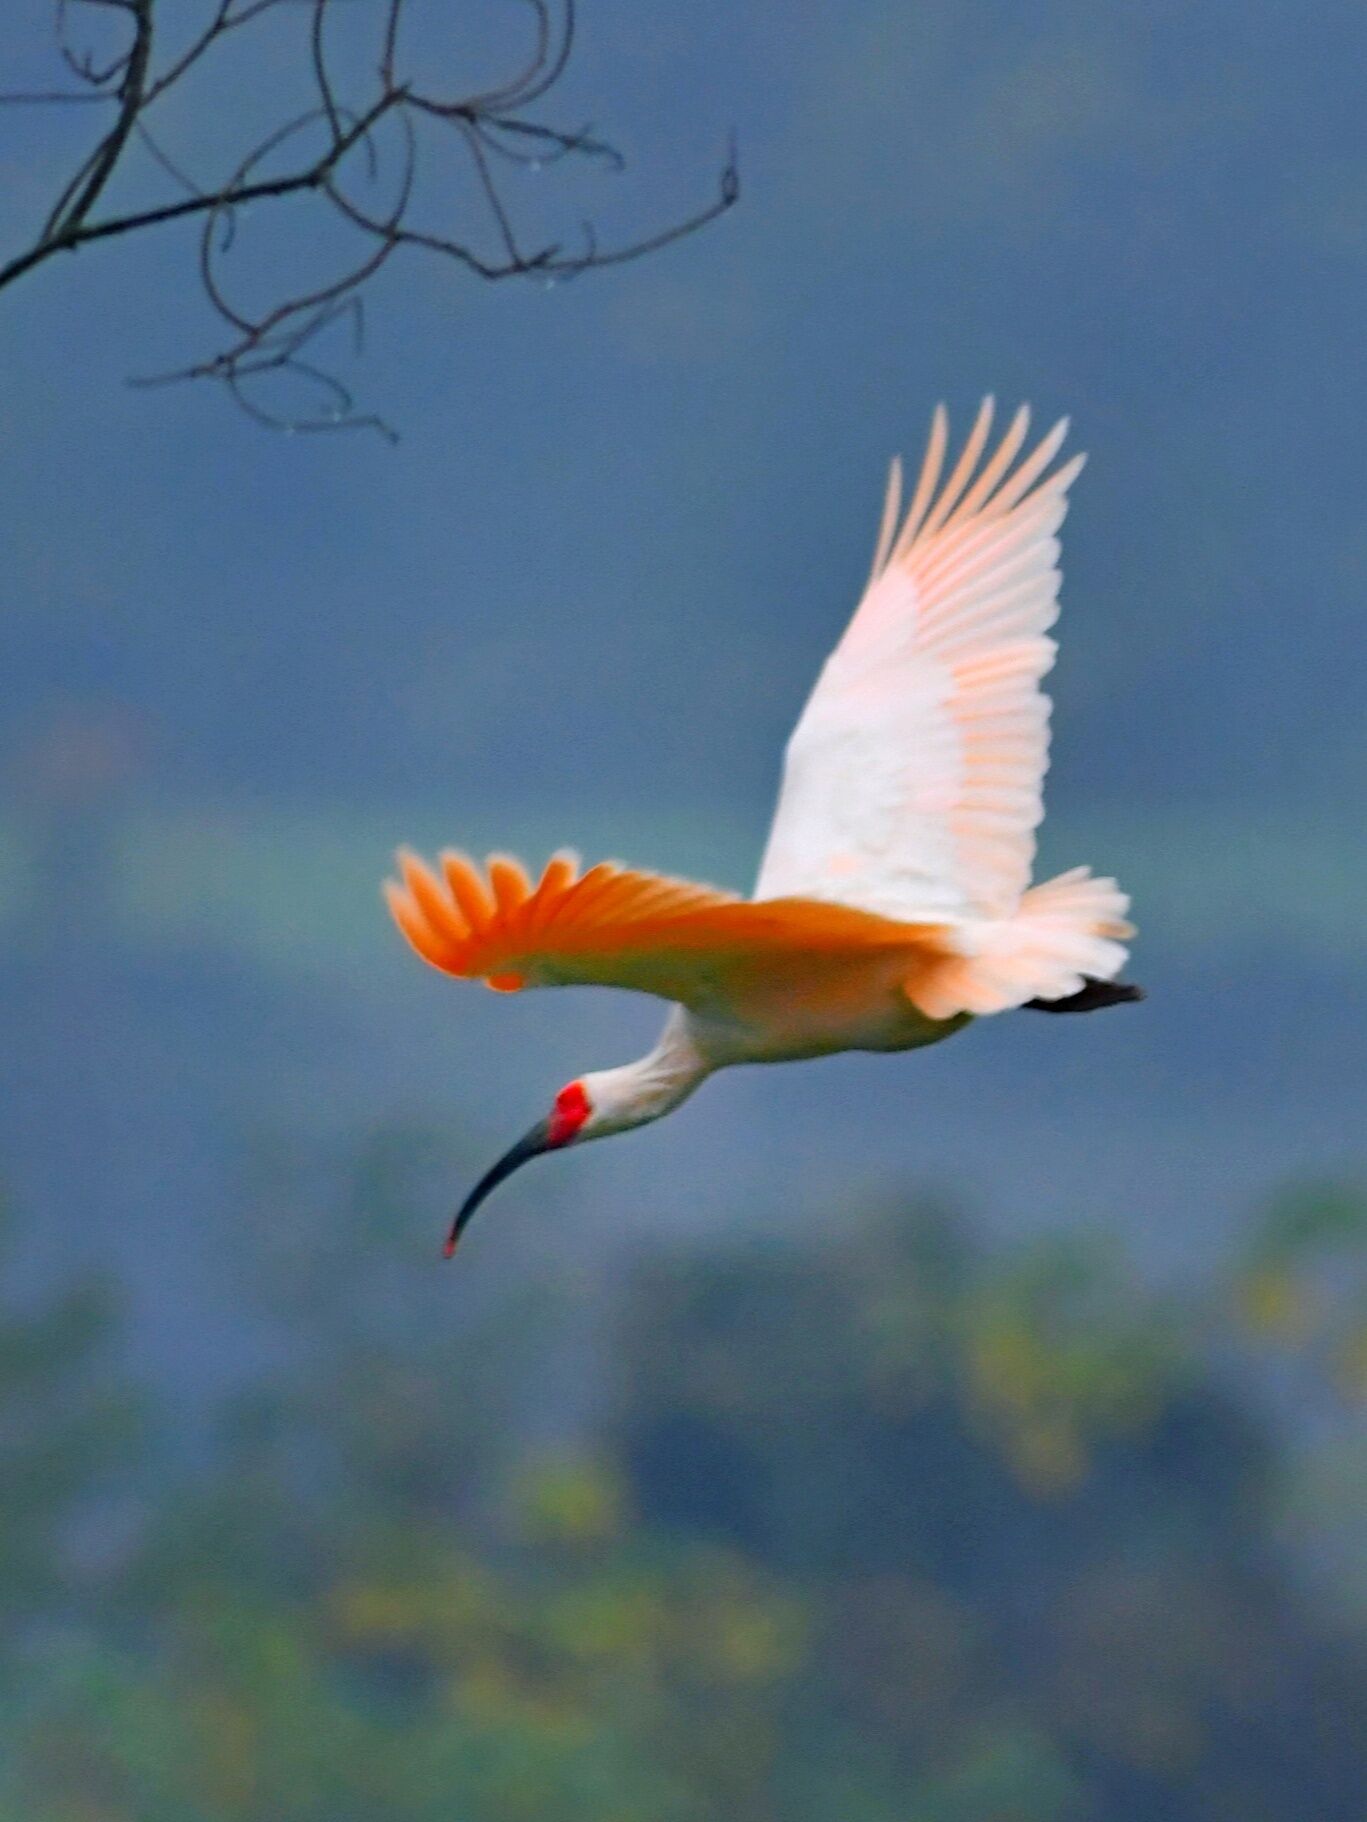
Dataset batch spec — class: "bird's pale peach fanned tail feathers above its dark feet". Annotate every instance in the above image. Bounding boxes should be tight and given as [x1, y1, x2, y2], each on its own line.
[908, 867, 1134, 1018]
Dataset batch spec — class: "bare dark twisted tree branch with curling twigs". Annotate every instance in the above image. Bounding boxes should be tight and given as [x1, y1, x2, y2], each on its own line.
[0, 0, 740, 435]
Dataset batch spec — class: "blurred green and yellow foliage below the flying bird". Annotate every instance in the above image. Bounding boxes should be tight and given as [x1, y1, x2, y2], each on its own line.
[0, 1158, 1367, 1822]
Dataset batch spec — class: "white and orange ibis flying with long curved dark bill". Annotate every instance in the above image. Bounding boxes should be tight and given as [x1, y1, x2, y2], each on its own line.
[385, 399, 1143, 1257]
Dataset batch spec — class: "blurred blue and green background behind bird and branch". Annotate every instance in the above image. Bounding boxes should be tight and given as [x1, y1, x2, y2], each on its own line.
[0, 0, 1367, 1822]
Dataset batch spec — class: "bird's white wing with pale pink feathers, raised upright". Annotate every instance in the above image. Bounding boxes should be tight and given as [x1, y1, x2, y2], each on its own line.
[755, 389, 1083, 924]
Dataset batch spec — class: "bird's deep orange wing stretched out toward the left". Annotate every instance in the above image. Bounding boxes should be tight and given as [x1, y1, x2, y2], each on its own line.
[385, 851, 935, 1011]
